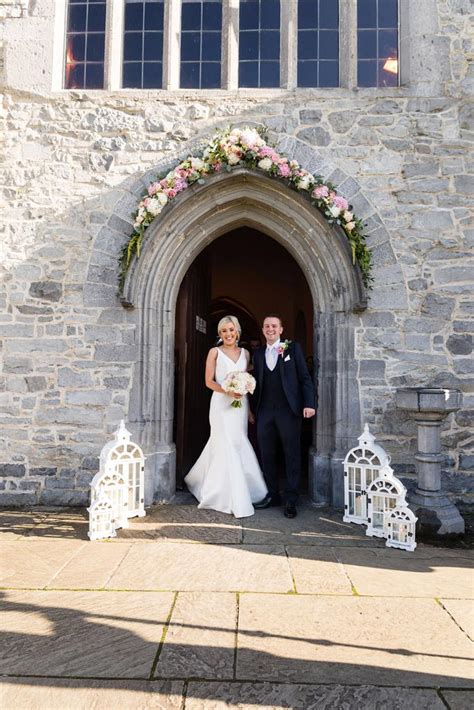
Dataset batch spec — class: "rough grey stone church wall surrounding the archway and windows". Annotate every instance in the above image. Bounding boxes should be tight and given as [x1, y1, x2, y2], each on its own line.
[0, 0, 474, 505]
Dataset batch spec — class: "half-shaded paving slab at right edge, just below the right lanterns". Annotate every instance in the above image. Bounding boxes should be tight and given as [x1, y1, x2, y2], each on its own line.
[336, 548, 474, 599]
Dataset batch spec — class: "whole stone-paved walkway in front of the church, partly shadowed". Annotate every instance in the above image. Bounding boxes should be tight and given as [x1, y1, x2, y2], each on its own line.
[0, 504, 474, 710]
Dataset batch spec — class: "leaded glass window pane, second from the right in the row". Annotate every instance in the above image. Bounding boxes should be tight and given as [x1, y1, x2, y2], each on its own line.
[298, 0, 339, 87]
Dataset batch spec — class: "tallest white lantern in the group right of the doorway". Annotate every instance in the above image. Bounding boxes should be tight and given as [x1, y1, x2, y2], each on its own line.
[343, 424, 390, 524]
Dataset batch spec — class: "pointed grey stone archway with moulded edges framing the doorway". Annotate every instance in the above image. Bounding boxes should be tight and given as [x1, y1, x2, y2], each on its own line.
[118, 168, 365, 505]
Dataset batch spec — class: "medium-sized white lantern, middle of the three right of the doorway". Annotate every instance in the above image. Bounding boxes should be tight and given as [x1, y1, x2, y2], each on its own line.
[365, 464, 406, 537]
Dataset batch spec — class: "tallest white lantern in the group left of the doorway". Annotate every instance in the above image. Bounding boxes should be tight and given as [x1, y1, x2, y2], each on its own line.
[100, 419, 146, 518]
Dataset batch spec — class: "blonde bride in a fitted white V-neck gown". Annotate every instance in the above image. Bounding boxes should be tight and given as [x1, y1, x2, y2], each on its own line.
[184, 316, 267, 518]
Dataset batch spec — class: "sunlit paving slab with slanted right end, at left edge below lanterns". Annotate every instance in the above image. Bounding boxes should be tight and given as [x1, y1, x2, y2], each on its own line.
[0, 538, 86, 589]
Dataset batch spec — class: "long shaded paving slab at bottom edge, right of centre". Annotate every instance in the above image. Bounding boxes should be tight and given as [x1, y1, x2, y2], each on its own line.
[186, 681, 446, 710]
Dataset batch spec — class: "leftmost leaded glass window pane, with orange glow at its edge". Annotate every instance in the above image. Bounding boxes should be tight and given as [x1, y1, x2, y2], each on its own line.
[64, 0, 106, 89]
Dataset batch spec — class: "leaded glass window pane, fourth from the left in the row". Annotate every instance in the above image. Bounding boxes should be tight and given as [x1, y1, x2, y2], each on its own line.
[239, 0, 280, 88]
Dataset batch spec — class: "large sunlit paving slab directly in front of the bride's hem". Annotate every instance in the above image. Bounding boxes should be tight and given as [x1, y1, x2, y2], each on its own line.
[106, 542, 293, 592]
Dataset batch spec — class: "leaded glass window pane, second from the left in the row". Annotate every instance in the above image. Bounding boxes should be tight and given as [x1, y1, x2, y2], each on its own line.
[123, 0, 164, 89]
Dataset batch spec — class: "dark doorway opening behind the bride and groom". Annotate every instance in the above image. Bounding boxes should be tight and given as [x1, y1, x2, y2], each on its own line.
[174, 227, 314, 492]
